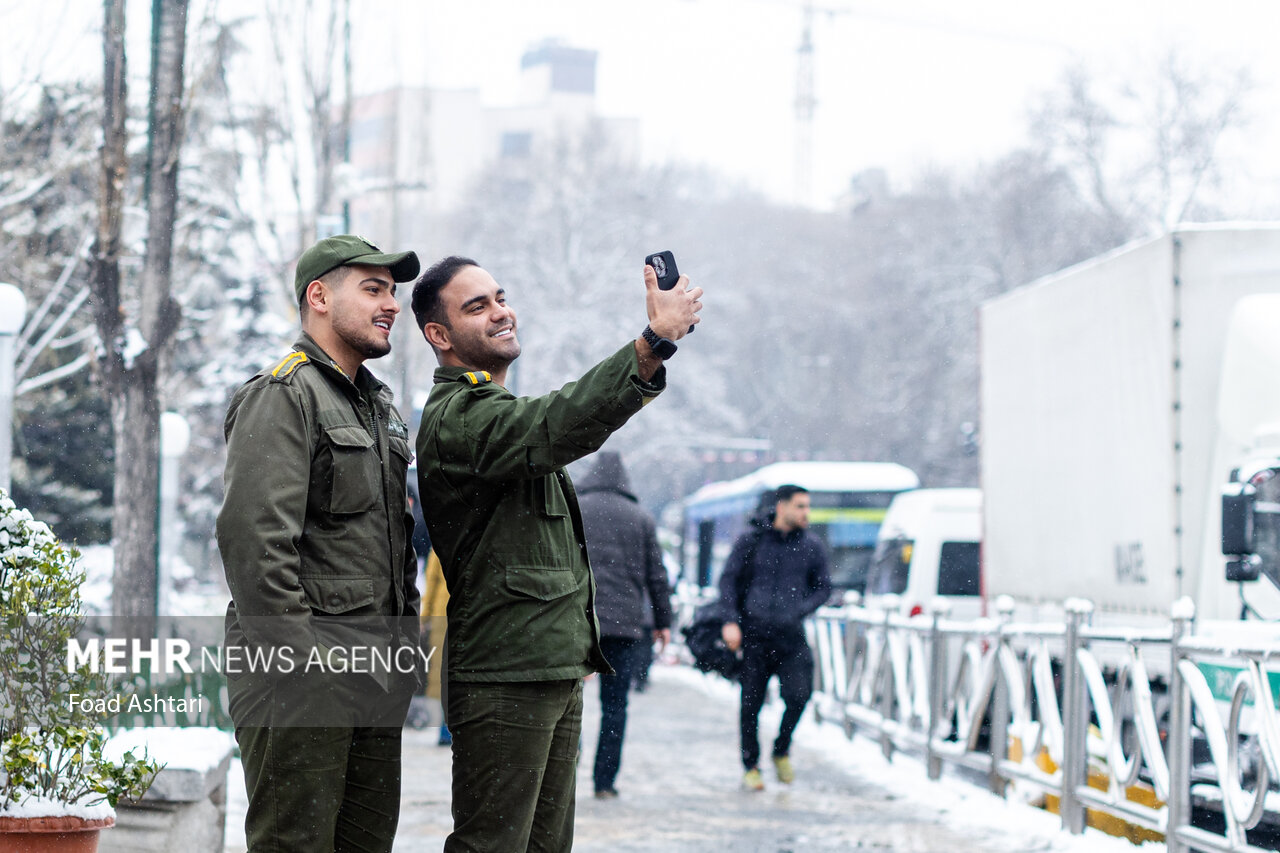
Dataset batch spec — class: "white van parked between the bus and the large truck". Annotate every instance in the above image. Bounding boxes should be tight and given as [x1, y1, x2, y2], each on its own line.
[865, 488, 982, 619]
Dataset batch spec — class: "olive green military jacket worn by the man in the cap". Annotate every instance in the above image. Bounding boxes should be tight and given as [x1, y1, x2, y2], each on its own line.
[216, 333, 421, 692]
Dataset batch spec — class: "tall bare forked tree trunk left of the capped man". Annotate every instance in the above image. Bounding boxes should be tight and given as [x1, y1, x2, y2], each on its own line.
[91, 0, 187, 638]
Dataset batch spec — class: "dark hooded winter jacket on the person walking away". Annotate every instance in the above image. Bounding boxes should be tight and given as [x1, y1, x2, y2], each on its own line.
[577, 451, 671, 639]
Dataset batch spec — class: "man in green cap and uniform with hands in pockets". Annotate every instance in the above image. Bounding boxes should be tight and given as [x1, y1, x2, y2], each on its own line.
[216, 234, 424, 853]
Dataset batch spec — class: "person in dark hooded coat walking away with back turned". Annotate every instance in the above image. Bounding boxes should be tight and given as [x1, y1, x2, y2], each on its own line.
[577, 451, 671, 799]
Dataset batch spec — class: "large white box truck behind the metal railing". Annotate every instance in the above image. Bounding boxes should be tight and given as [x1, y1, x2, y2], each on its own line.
[979, 224, 1280, 625]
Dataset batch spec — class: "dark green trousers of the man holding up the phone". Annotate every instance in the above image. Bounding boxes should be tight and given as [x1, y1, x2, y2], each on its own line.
[444, 679, 582, 853]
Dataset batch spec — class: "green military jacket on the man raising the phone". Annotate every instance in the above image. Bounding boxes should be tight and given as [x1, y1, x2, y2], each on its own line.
[417, 343, 666, 681]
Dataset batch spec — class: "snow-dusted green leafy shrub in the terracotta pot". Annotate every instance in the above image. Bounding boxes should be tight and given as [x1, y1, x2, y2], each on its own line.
[0, 491, 160, 812]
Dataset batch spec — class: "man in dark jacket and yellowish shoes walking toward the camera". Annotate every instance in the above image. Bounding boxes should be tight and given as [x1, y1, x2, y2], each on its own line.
[721, 485, 831, 790]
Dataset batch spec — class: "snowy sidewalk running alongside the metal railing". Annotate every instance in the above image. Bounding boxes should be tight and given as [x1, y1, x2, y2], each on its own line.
[227, 665, 1164, 853]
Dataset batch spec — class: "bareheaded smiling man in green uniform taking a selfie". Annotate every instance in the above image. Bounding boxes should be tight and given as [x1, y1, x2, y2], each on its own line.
[412, 257, 703, 853]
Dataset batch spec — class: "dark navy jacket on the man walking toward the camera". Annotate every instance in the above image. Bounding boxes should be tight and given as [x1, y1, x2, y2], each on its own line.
[719, 526, 831, 634]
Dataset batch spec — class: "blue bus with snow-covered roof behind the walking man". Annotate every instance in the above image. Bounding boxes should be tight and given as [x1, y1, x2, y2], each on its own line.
[680, 462, 920, 592]
